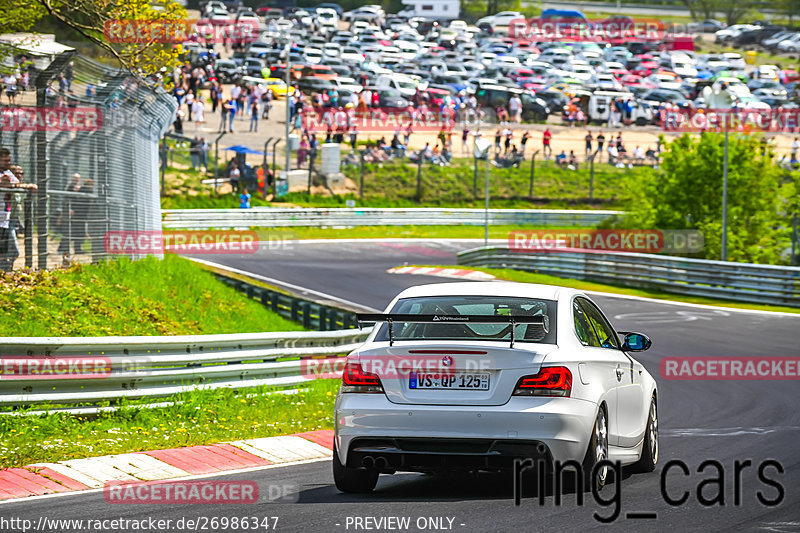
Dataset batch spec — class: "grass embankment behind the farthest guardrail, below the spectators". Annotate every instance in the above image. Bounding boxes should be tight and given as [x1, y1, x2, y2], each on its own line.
[161, 159, 653, 209]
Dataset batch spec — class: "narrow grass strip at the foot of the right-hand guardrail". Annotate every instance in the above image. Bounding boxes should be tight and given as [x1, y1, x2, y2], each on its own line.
[414, 265, 800, 314]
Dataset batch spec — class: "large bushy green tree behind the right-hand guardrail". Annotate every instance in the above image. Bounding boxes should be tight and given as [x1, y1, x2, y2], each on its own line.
[624, 133, 786, 264]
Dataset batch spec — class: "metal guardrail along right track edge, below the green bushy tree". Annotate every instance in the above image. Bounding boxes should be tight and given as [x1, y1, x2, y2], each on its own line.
[458, 246, 800, 307]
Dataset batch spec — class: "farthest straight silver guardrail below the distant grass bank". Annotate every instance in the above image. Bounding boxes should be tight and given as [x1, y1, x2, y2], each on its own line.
[162, 207, 622, 229]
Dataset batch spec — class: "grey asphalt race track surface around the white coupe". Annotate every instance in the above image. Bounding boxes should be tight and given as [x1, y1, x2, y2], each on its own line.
[0, 241, 800, 533]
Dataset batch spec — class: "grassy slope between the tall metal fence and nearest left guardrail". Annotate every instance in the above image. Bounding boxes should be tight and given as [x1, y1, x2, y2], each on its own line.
[0, 254, 302, 337]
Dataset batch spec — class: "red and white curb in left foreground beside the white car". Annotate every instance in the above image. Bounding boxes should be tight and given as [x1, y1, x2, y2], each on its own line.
[0, 430, 333, 501]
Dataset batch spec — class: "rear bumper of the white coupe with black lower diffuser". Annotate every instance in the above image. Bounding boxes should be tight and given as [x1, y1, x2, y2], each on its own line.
[335, 394, 597, 471]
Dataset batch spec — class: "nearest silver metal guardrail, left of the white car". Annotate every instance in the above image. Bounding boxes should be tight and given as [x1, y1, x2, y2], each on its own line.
[0, 329, 370, 406]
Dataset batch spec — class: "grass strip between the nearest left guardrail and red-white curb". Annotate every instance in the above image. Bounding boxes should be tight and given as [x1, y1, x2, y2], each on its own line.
[0, 379, 339, 469]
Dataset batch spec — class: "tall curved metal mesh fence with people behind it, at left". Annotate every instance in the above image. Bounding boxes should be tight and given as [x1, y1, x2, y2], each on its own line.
[0, 52, 176, 269]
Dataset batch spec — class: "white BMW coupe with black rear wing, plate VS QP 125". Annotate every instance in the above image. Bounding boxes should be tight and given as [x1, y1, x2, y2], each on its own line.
[333, 282, 658, 492]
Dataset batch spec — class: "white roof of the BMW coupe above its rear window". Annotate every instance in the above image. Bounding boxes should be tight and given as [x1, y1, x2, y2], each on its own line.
[397, 281, 568, 300]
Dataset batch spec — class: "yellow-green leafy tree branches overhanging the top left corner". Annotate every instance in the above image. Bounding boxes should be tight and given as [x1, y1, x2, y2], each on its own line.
[0, 0, 187, 76]
